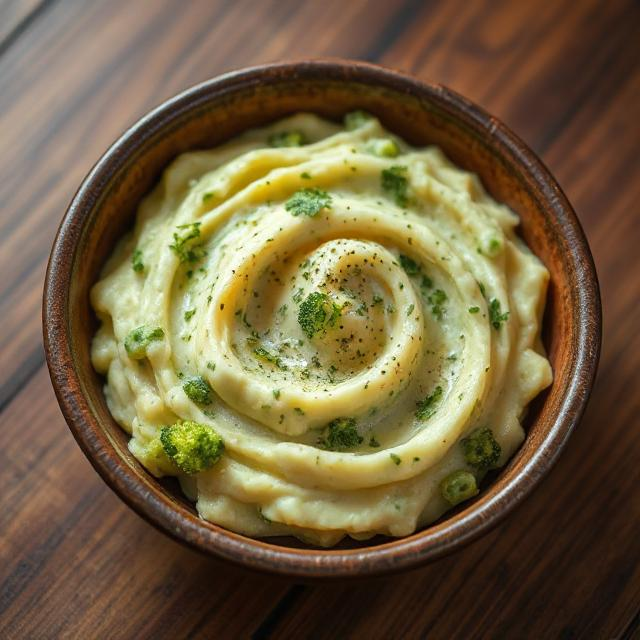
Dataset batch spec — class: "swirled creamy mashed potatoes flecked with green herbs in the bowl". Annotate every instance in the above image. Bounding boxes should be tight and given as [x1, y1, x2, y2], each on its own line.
[91, 113, 551, 546]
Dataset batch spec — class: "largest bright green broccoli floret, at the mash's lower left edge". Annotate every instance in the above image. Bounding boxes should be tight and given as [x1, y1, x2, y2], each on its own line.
[160, 420, 224, 474]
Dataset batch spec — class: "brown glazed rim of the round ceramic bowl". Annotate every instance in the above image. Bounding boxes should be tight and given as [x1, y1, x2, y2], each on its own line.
[43, 59, 601, 579]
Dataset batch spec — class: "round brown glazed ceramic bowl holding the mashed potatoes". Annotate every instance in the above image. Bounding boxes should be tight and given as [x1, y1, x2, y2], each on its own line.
[43, 60, 601, 578]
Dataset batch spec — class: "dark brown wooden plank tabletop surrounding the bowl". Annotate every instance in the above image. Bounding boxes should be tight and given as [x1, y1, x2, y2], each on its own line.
[0, 0, 640, 638]
